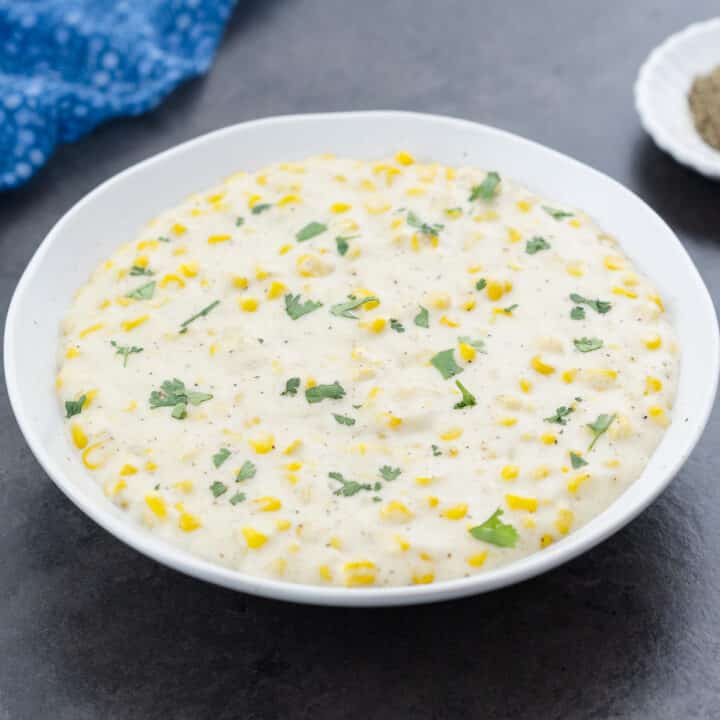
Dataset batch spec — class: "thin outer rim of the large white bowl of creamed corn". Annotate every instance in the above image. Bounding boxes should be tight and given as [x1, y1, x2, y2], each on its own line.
[4, 110, 720, 607]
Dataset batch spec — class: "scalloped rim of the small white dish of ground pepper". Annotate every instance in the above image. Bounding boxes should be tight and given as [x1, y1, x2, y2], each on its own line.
[633, 17, 720, 180]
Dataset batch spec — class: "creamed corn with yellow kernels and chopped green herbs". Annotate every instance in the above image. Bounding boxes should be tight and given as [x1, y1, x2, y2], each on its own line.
[57, 152, 678, 586]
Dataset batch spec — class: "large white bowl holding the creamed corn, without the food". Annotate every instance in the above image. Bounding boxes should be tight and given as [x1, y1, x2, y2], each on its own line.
[5, 112, 718, 606]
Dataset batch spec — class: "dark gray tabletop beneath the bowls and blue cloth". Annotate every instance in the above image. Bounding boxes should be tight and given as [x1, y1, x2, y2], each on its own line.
[0, 0, 720, 720]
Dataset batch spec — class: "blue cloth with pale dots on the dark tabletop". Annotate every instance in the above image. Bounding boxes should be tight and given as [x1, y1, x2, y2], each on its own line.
[0, 0, 234, 190]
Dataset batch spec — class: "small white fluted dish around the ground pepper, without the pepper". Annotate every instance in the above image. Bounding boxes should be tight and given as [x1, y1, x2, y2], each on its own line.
[635, 18, 720, 179]
